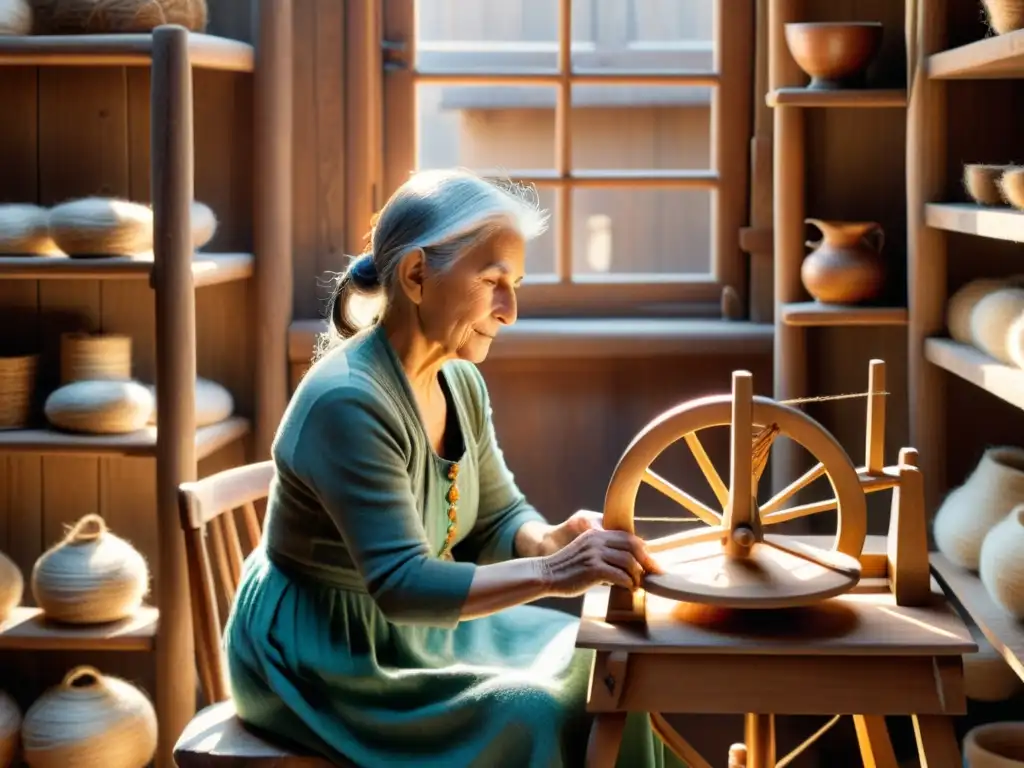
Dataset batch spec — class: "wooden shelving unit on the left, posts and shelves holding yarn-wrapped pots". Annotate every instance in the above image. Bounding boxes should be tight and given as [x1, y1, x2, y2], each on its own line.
[0, 0, 292, 768]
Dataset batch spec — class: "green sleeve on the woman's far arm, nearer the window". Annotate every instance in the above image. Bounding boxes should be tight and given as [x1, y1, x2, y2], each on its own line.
[453, 365, 547, 564]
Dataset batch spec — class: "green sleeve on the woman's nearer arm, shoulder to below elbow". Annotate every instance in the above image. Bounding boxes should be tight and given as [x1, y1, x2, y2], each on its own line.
[294, 386, 476, 628]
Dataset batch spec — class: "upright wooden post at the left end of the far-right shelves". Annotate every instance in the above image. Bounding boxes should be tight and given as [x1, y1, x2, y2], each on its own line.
[906, 0, 946, 514]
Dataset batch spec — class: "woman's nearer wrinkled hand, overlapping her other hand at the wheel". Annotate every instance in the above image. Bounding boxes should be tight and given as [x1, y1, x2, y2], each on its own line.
[541, 529, 662, 597]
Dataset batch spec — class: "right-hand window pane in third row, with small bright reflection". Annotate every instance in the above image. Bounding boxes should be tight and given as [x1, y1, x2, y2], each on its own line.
[572, 187, 713, 275]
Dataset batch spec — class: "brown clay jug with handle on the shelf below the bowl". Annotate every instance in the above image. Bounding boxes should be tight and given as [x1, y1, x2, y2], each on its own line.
[800, 219, 886, 304]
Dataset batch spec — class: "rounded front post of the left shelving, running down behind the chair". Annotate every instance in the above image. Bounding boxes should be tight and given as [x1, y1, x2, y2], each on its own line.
[150, 25, 196, 768]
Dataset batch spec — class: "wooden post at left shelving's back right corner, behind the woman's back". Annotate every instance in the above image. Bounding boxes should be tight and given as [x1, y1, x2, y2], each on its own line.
[253, 0, 293, 461]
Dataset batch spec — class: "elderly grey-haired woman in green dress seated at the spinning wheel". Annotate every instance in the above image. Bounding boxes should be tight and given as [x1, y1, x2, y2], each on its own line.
[225, 172, 679, 768]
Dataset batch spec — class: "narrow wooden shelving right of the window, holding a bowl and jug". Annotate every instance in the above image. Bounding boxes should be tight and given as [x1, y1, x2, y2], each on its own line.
[766, 0, 907, 492]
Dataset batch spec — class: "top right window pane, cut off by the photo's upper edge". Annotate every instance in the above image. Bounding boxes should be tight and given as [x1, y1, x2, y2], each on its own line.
[569, 0, 715, 72]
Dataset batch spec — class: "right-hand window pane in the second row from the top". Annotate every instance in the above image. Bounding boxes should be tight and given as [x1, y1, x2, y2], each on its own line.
[569, 85, 712, 171]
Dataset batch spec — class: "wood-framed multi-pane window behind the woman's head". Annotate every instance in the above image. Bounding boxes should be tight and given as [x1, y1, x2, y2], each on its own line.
[375, 0, 755, 316]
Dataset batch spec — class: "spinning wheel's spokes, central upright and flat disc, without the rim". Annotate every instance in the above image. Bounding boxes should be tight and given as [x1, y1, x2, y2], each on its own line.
[643, 371, 860, 607]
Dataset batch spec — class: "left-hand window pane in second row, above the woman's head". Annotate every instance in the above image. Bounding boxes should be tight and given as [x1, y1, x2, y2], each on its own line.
[416, 85, 555, 174]
